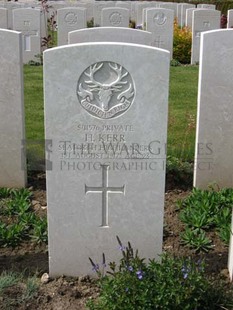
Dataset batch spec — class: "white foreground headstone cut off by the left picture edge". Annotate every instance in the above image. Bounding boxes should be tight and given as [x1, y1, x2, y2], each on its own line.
[0, 29, 26, 188]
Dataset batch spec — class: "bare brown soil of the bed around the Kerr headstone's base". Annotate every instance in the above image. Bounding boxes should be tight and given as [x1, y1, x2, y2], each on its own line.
[0, 173, 229, 310]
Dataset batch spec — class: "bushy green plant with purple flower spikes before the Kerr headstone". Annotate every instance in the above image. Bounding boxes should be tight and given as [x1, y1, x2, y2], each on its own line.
[87, 238, 231, 310]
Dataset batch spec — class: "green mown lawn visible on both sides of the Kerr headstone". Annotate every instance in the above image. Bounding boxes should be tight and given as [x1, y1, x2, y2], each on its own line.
[24, 65, 198, 167]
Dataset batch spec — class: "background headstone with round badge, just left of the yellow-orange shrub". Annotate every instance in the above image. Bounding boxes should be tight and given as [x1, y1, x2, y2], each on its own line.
[146, 8, 174, 59]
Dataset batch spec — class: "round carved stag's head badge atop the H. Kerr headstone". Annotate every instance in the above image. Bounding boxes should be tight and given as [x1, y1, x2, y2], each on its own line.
[77, 61, 135, 119]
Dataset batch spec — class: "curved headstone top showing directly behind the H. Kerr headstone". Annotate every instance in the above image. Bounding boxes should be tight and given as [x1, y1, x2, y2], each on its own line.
[68, 27, 153, 45]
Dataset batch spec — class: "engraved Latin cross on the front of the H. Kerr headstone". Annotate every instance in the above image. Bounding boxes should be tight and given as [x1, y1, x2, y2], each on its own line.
[85, 165, 125, 227]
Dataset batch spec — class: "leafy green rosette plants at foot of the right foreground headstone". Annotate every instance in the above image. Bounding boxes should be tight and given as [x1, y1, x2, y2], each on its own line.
[178, 188, 233, 252]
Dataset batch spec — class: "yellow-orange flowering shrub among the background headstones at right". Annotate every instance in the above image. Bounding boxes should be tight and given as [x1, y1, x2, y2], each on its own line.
[173, 19, 192, 64]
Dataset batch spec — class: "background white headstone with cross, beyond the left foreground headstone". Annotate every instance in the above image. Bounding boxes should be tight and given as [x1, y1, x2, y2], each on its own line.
[13, 9, 41, 63]
